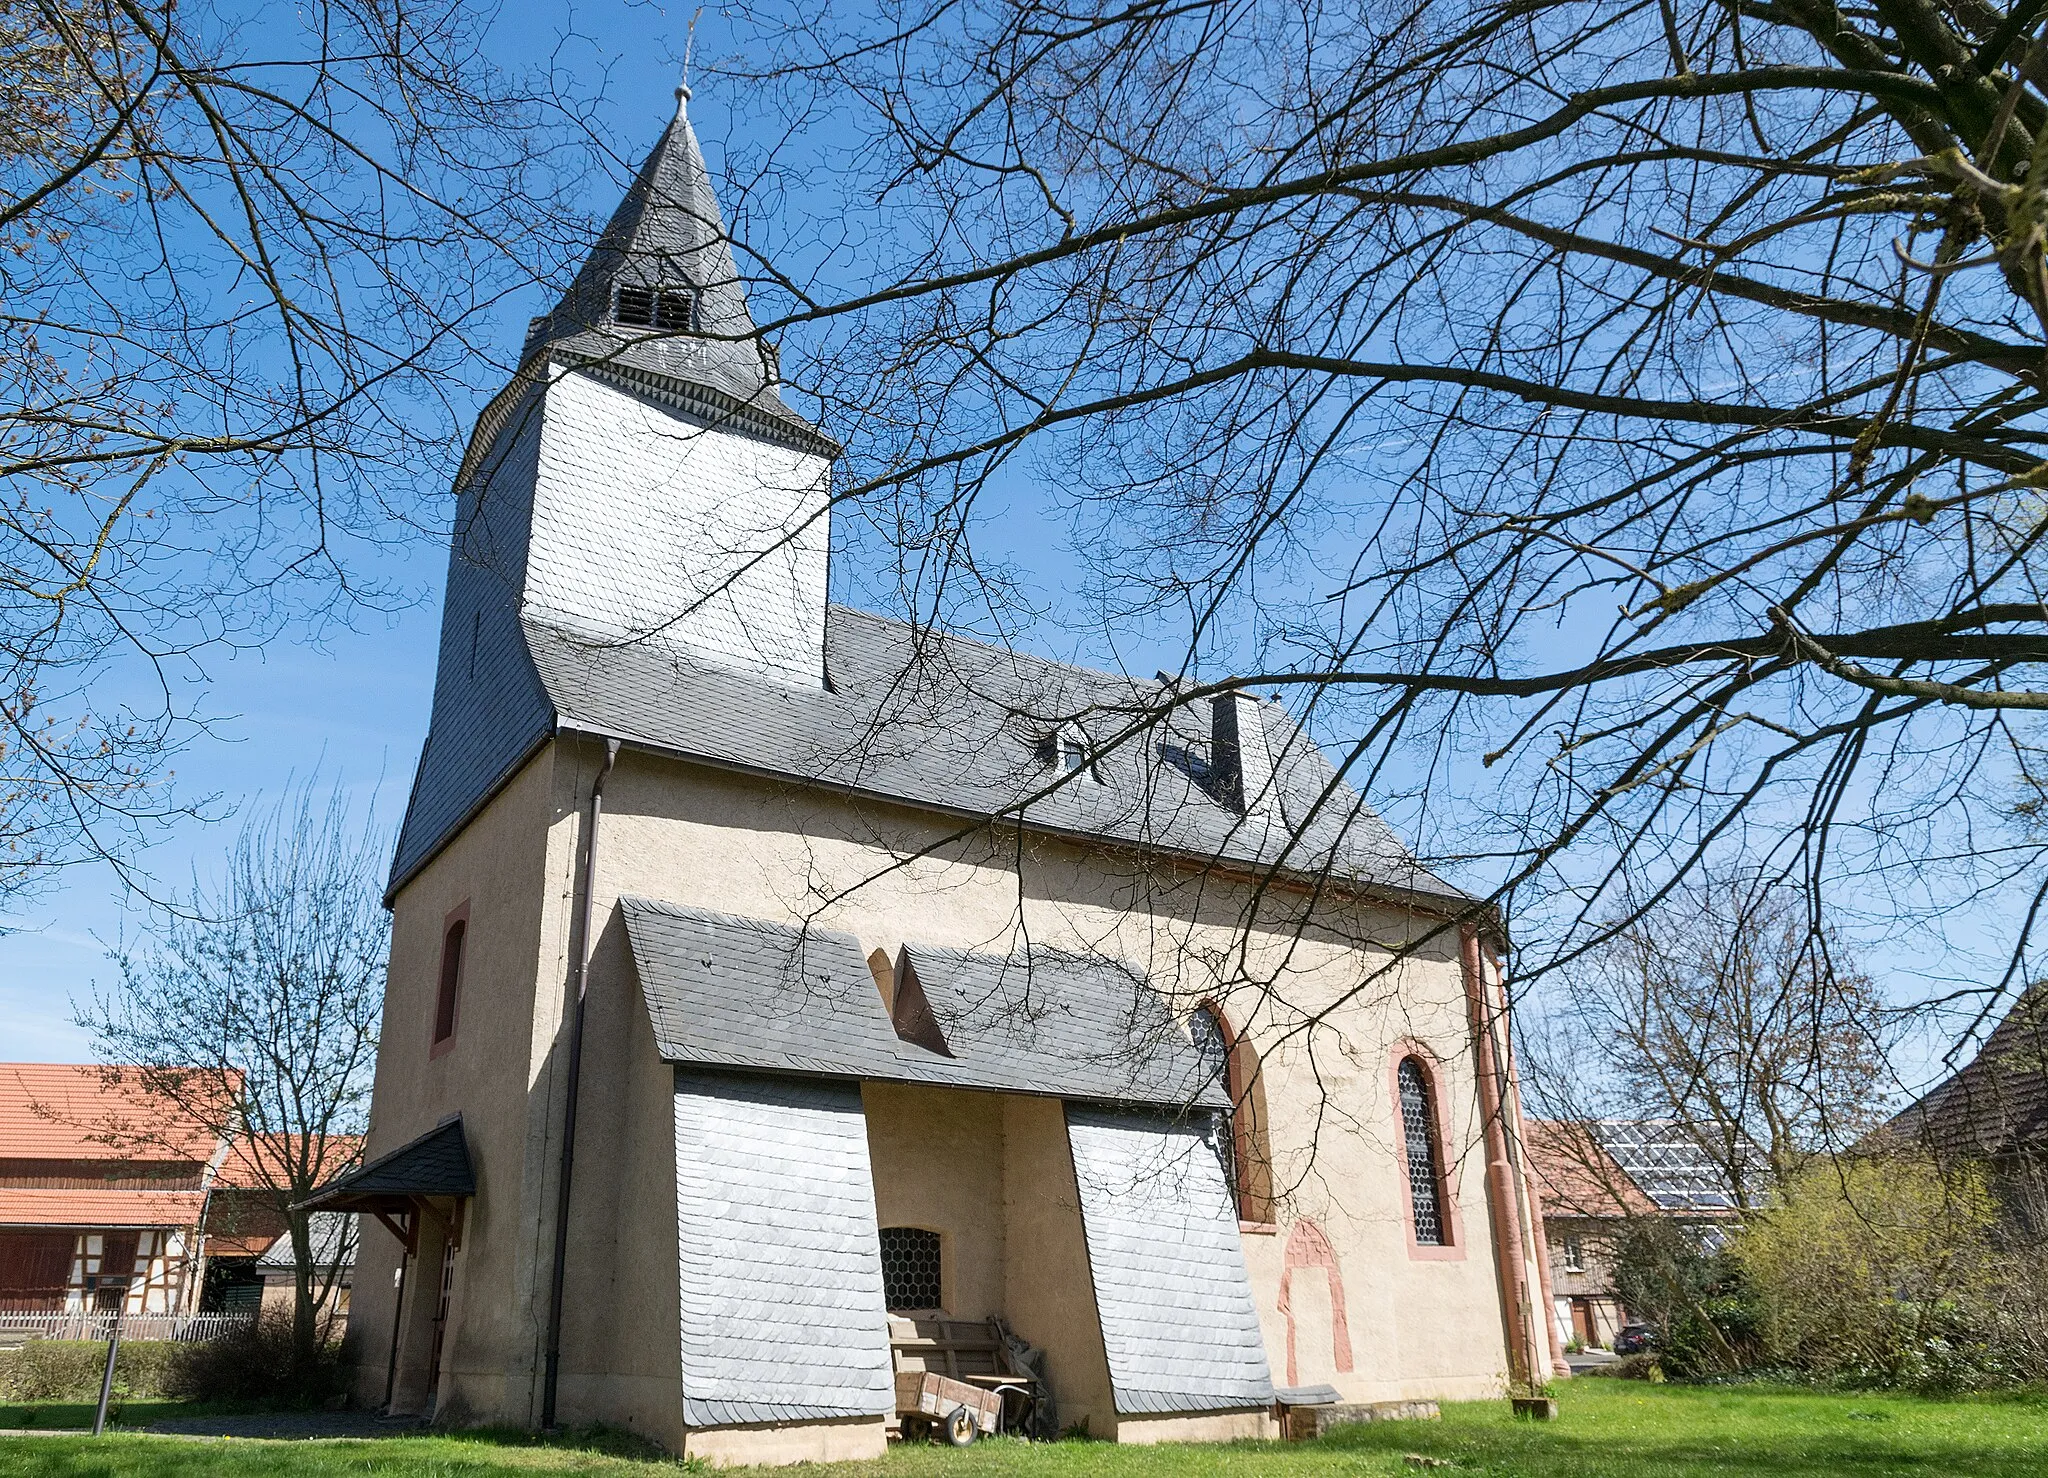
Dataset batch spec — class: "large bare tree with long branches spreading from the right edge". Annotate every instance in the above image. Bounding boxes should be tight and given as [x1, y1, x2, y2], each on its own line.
[667, 0, 2048, 1048]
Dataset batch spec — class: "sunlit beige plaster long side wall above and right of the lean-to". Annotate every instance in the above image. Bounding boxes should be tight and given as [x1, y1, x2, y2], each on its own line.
[569, 753, 1531, 1400]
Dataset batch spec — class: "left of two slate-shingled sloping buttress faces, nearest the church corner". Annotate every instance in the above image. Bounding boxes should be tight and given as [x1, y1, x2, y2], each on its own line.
[676, 1071, 895, 1427]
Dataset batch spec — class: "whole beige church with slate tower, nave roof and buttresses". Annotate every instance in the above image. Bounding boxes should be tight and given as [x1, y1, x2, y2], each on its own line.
[309, 86, 1554, 1462]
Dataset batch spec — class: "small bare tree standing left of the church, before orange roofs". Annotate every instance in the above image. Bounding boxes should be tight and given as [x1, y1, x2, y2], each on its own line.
[78, 780, 391, 1359]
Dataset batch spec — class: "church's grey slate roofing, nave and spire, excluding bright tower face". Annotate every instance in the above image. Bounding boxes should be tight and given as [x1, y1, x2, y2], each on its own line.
[387, 97, 1468, 905]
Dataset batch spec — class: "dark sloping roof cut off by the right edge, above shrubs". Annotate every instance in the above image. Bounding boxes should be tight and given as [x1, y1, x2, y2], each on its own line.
[1888, 985, 2048, 1159]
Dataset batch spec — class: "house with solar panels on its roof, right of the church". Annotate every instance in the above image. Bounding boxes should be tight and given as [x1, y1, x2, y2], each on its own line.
[1526, 1120, 1737, 1347]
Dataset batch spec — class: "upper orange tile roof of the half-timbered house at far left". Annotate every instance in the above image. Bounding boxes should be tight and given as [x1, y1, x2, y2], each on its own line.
[0, 1062, 219, 1163]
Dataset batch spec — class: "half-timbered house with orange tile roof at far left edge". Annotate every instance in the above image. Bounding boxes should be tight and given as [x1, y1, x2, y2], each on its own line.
[0, 1062, 225, 1314]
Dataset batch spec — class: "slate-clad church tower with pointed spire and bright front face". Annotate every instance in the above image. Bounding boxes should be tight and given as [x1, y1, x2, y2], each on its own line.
[391, 88, 838, 890]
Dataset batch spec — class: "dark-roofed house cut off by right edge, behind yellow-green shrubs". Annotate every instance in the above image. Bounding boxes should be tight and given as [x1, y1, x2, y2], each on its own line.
[1886, 985, 2048, 1236]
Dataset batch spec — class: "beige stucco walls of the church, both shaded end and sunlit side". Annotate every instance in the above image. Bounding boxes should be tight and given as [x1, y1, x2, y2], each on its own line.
[350, 735, 1542, 1462]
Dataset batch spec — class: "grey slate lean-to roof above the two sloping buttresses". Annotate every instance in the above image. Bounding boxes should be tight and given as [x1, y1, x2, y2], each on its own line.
[618, 897, 1227, 1107]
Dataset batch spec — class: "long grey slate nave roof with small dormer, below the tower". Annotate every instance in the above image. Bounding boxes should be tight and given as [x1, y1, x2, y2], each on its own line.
[393, 606, 1466, 903]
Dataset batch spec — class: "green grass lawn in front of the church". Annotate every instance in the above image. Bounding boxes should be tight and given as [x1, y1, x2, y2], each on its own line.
[0, 1380, 2048, 1478]
